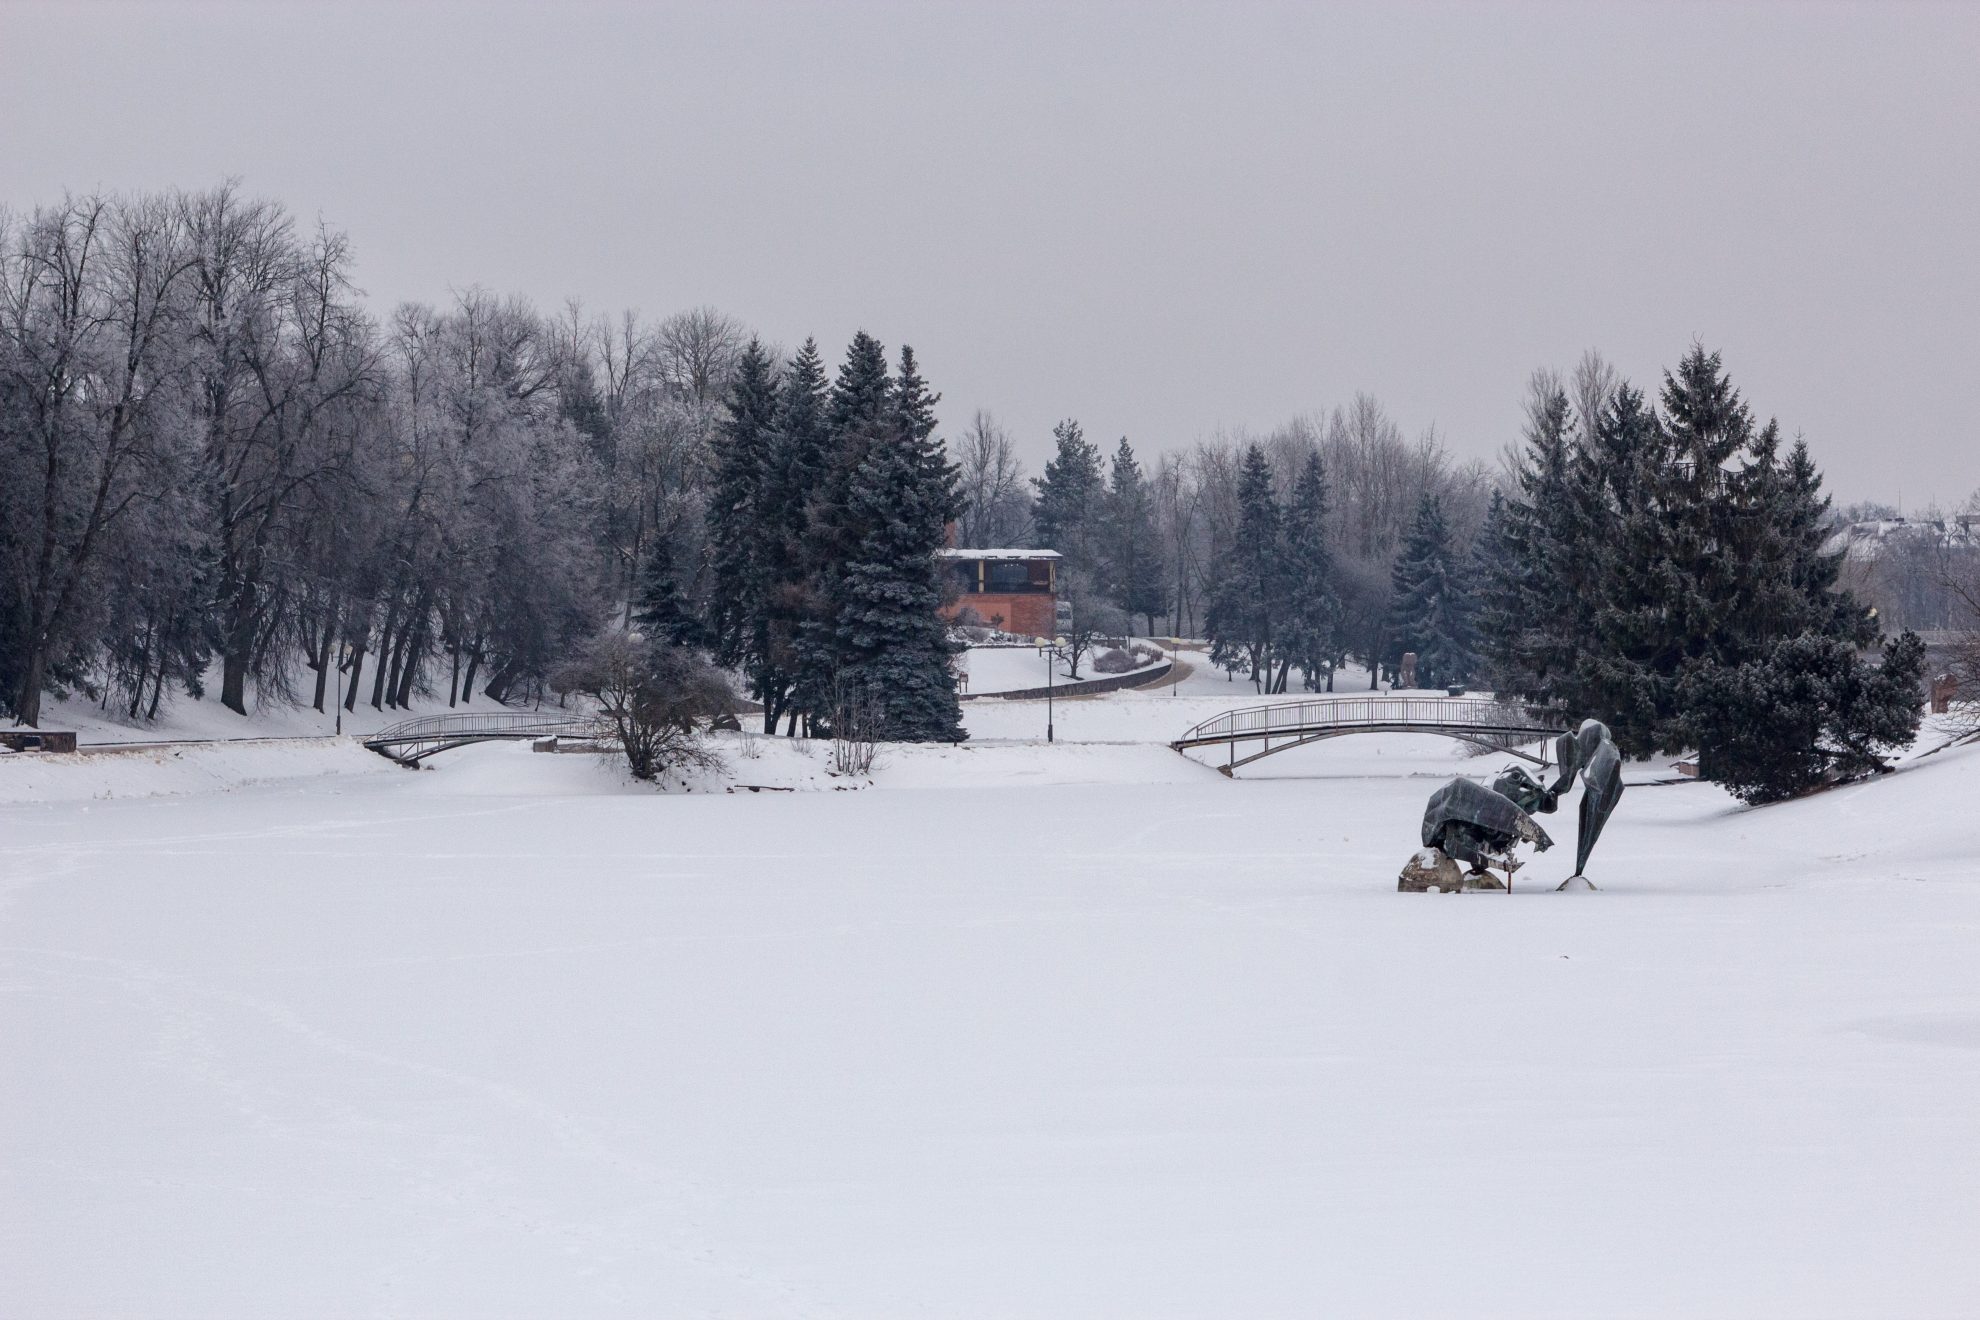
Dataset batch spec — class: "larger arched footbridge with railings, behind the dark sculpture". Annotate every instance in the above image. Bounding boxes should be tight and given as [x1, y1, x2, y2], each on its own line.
[1168, 697, 1568, 776]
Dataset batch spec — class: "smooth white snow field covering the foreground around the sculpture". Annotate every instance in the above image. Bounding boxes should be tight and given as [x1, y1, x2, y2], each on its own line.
[0, 675, 1980, 1320]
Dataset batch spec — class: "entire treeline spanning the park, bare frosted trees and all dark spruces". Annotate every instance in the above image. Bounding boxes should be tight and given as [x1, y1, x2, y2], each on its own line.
[0, 186, 1923, 798]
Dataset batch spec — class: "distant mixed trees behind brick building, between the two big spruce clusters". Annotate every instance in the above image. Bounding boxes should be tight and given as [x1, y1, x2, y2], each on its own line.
[958, 396, 1493, 691]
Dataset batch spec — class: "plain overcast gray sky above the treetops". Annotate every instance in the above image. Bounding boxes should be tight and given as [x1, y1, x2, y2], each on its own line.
[0, 0, 1980, 507]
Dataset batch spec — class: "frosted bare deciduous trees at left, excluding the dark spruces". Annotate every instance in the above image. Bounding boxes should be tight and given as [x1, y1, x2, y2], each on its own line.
[0, 186, 746, 722]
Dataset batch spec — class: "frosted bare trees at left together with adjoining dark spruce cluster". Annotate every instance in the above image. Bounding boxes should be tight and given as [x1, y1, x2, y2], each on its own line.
[0, 186, 958, 736]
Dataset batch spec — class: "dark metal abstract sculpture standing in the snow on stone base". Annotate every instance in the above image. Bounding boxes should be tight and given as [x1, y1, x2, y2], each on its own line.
[1398, 720, 1622, 893]
